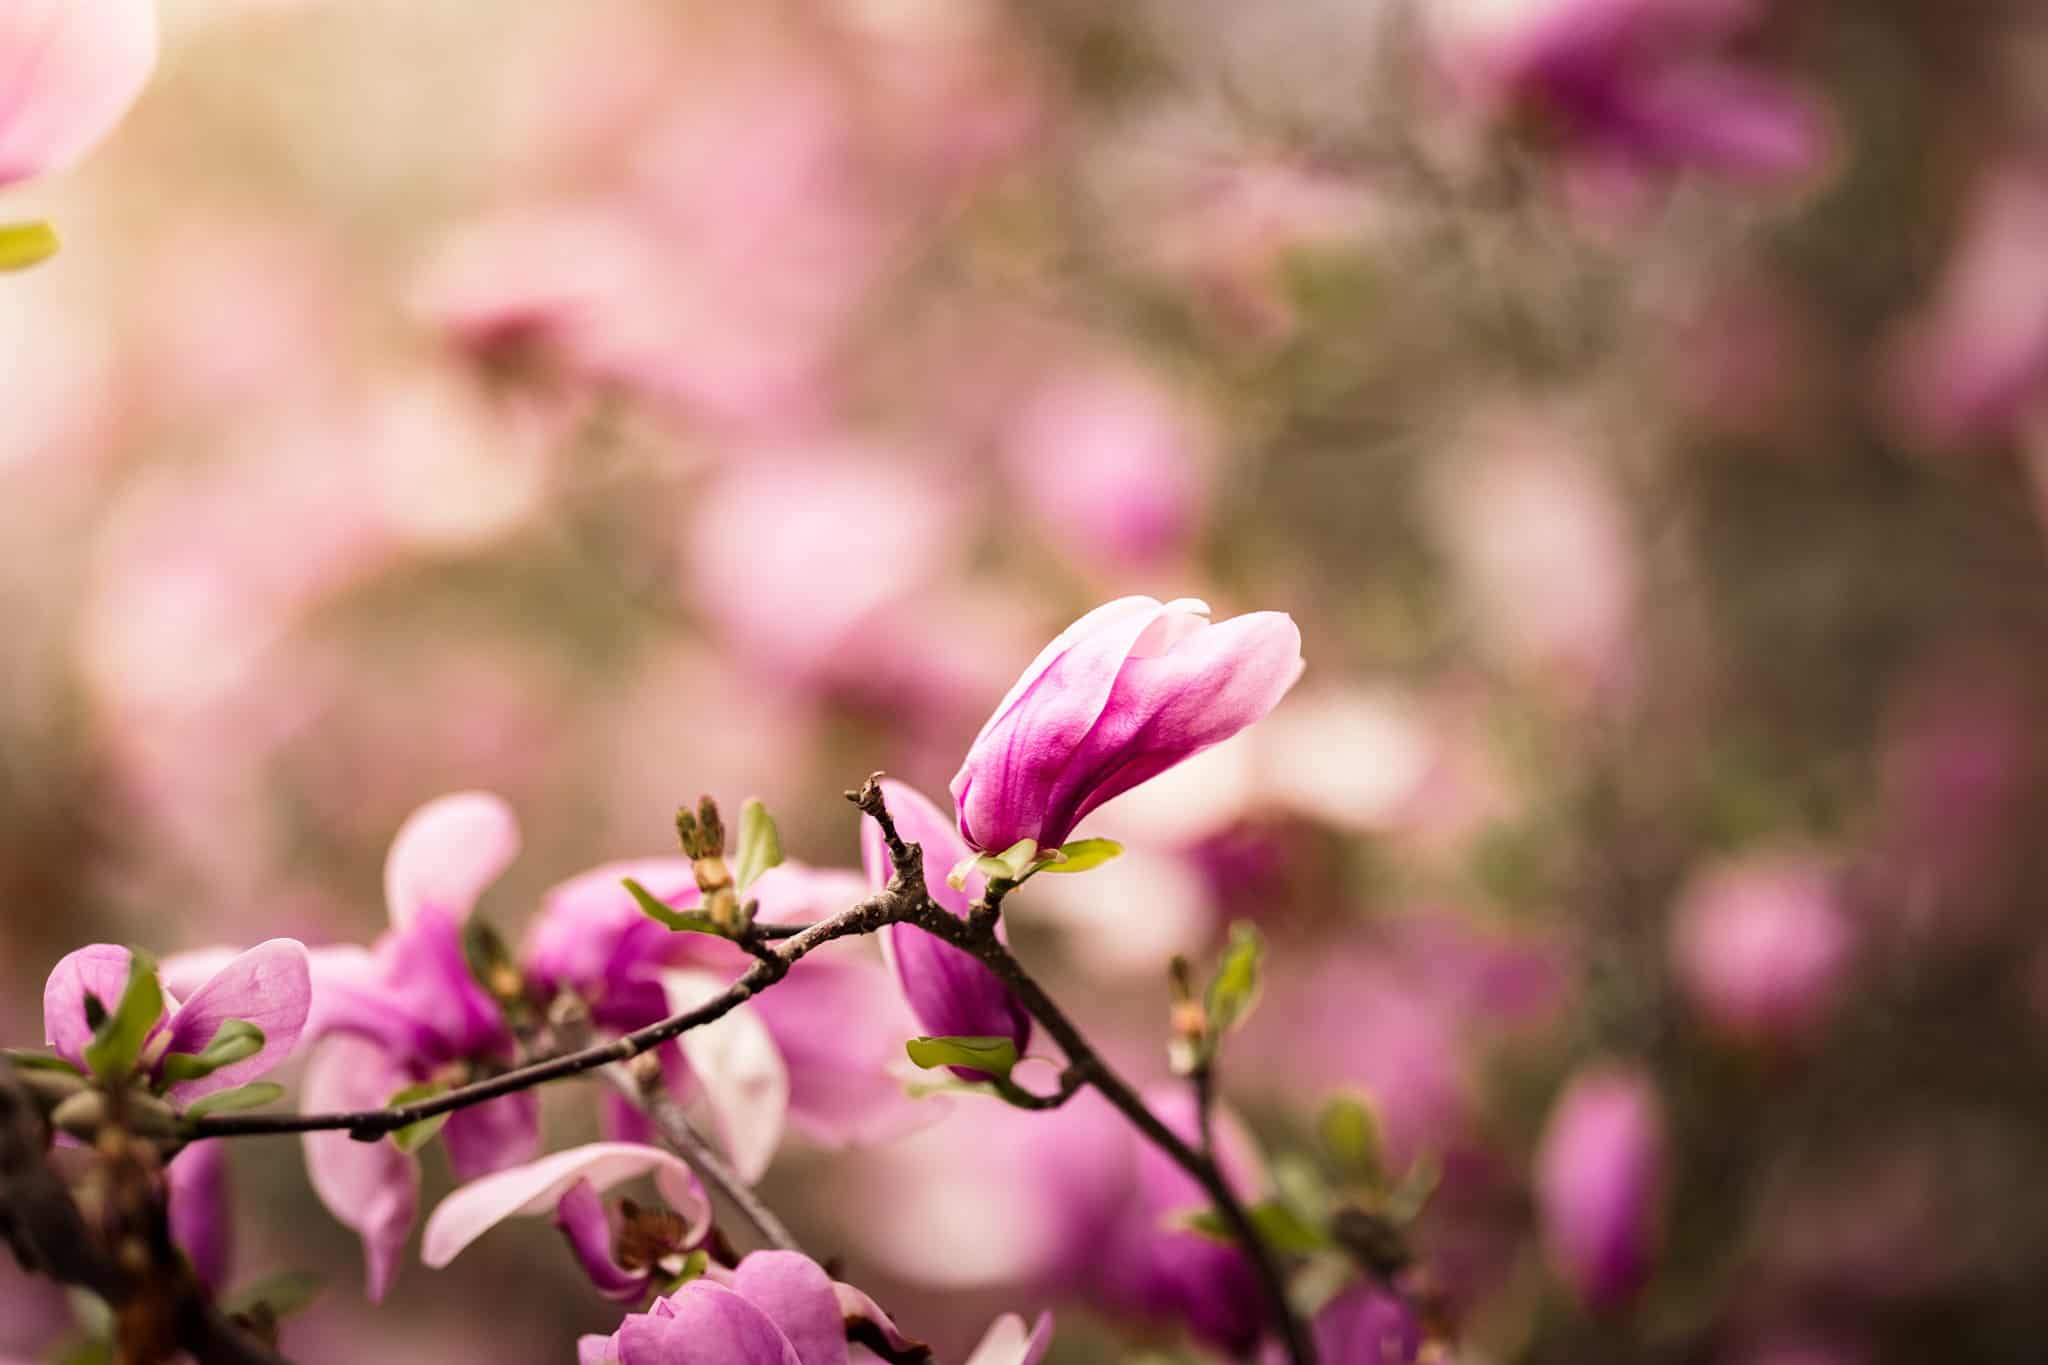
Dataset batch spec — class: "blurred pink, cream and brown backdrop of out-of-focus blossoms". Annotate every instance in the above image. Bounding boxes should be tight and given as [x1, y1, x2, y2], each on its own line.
[0, 0, 2048, 1365]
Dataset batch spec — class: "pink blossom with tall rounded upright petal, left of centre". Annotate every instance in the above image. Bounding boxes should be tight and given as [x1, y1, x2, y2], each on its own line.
[301, 792, 541, 1300]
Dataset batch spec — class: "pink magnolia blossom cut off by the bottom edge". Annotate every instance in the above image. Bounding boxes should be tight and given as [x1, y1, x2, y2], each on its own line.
[575, 1250, 1053, 1365]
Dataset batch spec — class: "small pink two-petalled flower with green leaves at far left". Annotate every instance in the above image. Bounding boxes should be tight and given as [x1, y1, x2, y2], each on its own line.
[43, 939, 313, 1099]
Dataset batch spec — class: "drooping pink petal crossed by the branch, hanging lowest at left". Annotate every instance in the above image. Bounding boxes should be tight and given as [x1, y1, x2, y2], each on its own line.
[301, 1038, 420, 1304]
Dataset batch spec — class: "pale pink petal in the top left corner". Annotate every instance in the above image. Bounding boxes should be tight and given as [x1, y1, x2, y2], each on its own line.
[0, 0, 156, 186]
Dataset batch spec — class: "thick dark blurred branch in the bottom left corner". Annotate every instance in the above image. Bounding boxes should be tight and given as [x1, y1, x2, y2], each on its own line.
[0, 1060, 285, 1365]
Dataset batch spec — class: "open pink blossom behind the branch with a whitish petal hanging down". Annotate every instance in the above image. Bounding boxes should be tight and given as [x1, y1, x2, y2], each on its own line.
[524, 857, 930, 1173]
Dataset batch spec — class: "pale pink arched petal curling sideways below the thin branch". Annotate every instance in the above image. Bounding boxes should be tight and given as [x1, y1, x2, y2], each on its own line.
[420, 1142, 711, 1269]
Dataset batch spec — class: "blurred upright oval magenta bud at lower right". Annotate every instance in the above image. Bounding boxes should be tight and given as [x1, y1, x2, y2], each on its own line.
[1534, 1066, 1665, 1308]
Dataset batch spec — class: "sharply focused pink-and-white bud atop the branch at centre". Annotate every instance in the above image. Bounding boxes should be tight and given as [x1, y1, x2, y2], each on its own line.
[952, 598, 1303, 851]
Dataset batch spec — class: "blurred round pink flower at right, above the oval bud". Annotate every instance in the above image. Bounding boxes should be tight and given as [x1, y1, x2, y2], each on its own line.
[1671, 855, 1855, 1042]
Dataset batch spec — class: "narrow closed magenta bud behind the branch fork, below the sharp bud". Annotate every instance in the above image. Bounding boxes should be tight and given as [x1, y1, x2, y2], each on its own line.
[860, 780, 1030, 1081]
